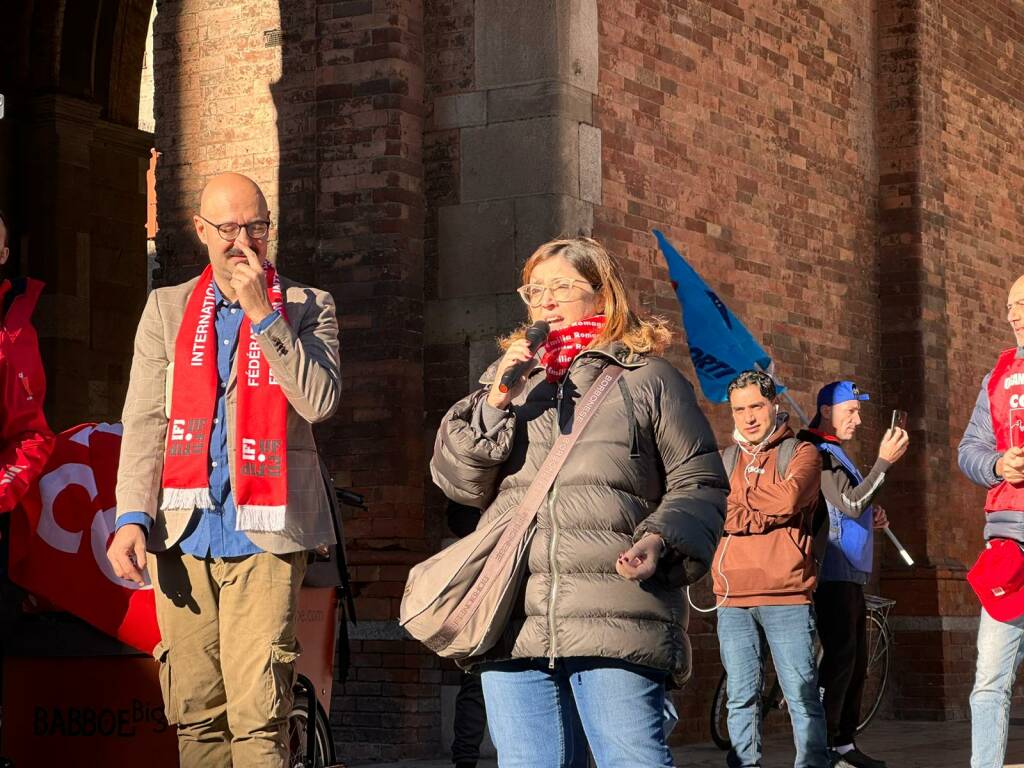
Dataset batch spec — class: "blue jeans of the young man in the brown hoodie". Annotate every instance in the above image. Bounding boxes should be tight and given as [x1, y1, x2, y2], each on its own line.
[718, 605, 828, 768]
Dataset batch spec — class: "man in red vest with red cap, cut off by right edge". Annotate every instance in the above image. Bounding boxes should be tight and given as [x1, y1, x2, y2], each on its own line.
[958, 276, 1024, 768]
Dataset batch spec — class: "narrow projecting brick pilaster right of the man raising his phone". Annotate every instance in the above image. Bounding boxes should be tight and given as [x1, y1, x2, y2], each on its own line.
[879, 3, 950, 718]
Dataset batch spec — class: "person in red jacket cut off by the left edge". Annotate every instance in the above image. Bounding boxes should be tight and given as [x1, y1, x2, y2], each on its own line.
[0, 207, 53, 514]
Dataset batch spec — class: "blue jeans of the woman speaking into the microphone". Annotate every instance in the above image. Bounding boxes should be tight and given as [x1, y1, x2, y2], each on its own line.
[482, 657, 672, 768]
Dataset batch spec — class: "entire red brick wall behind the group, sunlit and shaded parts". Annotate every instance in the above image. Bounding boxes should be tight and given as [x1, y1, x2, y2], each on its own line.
[138, 0, 1024, 761]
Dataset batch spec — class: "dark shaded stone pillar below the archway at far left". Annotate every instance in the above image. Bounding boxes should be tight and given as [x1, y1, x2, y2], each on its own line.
[24, 95, 152, 429]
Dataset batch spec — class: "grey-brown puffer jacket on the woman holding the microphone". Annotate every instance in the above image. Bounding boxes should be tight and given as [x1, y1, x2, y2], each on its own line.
[430, 343, 729, 677]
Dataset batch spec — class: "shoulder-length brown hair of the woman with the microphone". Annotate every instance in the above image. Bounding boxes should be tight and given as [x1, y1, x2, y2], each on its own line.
[501, 238, 672, 354]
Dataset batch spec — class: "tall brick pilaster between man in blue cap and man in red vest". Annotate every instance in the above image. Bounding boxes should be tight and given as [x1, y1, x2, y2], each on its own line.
[878, 0, 970, 720]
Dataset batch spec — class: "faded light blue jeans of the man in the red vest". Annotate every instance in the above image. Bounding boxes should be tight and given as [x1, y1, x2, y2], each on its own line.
[971, 608, 1024, 768]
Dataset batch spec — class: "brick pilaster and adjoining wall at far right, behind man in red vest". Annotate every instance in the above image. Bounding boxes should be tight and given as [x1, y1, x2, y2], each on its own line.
[881, 1, 1024, 719]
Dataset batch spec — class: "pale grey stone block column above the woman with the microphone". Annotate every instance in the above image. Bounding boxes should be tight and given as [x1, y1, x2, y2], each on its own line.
[426, 0, 601, 393]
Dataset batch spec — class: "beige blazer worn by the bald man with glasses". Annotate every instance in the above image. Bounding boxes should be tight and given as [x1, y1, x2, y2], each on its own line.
[117, 278, 341, 554]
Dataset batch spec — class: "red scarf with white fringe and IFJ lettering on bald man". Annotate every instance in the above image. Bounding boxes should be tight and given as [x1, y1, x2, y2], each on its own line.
[161, 263, 288, 531]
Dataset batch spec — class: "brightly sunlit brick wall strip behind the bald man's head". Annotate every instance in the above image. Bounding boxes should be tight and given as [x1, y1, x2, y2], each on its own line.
[153, 0, 284, 286]
